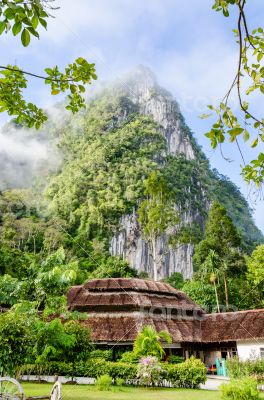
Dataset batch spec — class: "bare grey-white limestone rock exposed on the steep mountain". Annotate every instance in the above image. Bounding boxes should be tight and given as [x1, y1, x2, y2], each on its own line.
[110, 67, 203, 279]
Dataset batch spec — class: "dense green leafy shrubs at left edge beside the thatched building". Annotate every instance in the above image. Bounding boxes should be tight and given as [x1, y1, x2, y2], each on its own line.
[0, 306, 92, 375]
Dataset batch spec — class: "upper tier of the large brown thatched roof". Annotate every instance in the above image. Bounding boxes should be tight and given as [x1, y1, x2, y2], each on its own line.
[68, 278, 202, 314]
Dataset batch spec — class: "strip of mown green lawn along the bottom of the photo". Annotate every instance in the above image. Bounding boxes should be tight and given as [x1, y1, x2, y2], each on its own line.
[22, 383, 223, 400]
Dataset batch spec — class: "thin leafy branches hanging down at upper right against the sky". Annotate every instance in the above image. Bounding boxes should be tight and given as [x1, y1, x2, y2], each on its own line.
[202, 0, 264, 186]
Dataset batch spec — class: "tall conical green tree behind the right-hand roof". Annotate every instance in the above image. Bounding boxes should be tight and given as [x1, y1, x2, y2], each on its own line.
[183, 203, 262, 312]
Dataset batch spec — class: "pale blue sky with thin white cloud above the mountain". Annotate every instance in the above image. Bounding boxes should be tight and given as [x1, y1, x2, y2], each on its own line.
[1, 0, 264, 232]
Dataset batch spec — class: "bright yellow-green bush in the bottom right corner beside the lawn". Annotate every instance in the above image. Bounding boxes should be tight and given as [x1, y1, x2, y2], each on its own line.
[220, 377, 259, 400]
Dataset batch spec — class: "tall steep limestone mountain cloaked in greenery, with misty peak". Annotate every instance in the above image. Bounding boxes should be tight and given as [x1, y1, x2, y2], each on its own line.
[0, 67, 263, 279]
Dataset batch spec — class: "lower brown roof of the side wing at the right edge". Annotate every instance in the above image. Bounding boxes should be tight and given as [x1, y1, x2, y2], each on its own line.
[202, 309, 264, 342]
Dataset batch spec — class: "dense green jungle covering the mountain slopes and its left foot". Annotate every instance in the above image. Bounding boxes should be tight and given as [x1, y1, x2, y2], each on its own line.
[0, 86, 263, 311]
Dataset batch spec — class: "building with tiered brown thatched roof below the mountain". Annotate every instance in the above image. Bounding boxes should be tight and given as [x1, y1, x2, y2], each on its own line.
[68, 278, 264, 364]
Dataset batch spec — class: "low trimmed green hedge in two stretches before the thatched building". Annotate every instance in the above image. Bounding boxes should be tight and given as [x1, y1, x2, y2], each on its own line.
[20, 358, 206, 388]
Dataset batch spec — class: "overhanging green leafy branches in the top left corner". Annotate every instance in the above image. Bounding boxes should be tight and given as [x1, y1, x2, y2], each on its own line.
[0, 0, 97, 129]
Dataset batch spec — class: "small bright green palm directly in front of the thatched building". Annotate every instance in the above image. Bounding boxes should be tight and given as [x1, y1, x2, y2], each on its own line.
[133, 325, 172, 359]
